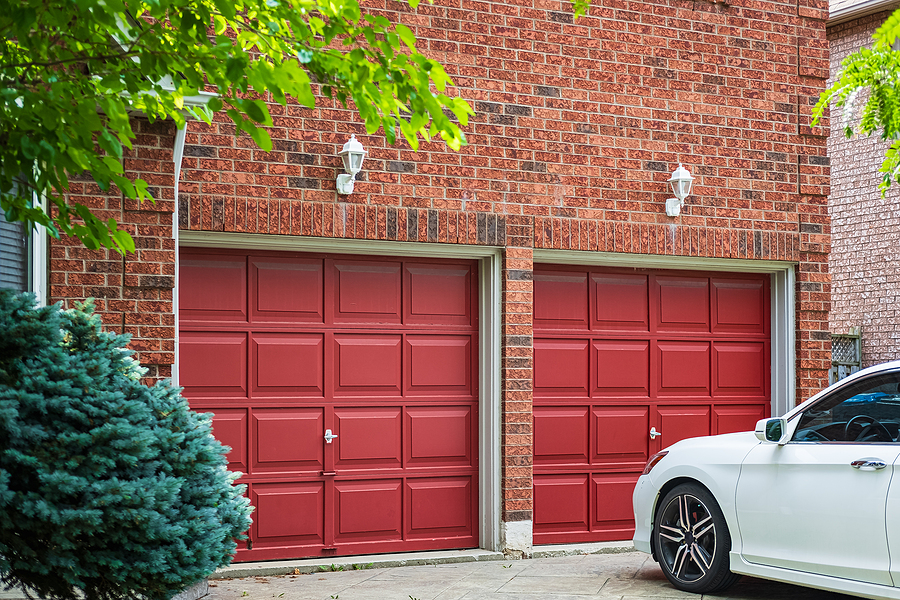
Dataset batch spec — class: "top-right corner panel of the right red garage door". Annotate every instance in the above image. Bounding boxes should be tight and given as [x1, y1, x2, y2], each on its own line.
[711, 278, 768, 334]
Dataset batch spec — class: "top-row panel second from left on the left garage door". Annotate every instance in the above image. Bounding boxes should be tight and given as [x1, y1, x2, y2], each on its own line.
[250, 257, 325, 323]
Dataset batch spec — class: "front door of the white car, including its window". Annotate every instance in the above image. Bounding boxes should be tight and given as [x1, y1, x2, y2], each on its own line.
[736, 373, 900, 585]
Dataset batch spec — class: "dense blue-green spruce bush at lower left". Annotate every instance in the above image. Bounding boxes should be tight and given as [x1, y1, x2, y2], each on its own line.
[0, 290, 250, 600]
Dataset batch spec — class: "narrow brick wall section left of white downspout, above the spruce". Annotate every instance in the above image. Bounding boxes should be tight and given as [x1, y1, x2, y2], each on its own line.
[50, 120, 175, 383]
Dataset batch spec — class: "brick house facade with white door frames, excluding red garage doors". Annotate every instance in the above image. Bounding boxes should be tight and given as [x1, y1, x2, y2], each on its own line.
[50, 0, 831, 558]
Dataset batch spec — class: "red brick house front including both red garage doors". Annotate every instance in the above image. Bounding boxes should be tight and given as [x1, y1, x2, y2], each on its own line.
[44, 0, 830, 559]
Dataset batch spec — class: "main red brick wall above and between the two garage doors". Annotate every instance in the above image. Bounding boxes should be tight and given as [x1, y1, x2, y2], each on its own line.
[58, 0, 830, 536]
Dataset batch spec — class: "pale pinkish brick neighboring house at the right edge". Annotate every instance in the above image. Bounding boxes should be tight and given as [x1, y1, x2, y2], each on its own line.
[828, 0, 900, 367]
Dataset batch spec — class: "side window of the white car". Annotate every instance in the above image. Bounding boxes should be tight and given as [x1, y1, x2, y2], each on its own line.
[792, 373, 900, 444]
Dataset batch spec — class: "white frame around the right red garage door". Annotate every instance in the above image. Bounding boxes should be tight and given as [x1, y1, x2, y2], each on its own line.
[534, 249, 797, 416]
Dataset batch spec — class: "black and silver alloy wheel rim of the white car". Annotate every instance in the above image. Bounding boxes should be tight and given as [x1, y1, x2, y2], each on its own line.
[657, 494, 716, 583]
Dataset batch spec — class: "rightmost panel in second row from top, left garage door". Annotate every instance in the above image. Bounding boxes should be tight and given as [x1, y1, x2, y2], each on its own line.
[406, 335, 472, 396]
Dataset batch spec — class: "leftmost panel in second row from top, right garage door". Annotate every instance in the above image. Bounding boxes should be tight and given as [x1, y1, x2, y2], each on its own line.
[534, 339, 589, 396]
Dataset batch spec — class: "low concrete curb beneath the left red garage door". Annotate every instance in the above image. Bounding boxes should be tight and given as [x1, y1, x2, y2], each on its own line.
[209, 550, 509, 579]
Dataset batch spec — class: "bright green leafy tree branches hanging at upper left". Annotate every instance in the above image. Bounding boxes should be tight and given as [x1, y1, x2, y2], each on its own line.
[0, 0, 590, 252]
